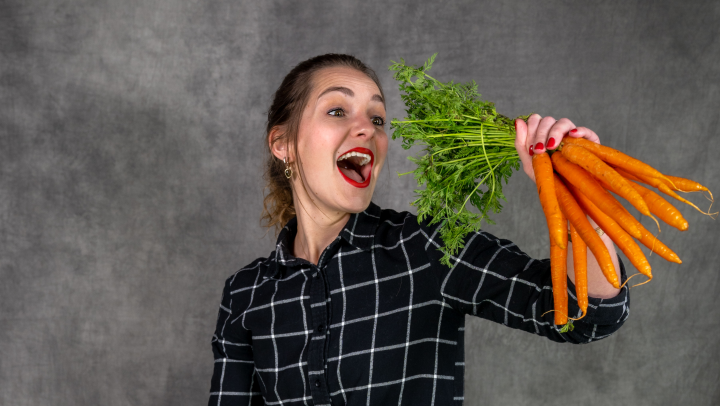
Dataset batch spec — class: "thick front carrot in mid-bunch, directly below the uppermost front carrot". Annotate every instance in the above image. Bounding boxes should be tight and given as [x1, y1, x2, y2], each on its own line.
[552, 153, 642, 238]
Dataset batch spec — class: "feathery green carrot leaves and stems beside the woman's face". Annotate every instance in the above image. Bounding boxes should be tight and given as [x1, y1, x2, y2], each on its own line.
[390, 54, 527, 266]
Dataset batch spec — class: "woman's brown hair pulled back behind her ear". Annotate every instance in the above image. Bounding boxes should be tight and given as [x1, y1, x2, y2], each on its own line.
[260, 54, 385, 235]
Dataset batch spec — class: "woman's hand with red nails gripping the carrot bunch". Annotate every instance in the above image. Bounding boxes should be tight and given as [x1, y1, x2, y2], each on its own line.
[515, 114, 600, 182]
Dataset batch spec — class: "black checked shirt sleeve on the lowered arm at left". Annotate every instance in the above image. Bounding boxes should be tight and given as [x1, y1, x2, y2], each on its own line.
[208, 279, 265, 406]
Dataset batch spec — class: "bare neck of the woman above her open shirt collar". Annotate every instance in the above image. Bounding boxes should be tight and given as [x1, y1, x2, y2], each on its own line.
[293, 200, 350, 264]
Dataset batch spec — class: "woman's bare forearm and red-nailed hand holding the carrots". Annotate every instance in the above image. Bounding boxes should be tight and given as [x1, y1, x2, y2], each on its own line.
[515, 114, 620, 299]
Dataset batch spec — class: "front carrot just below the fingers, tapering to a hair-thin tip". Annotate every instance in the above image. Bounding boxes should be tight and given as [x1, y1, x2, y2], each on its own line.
[562, 144, 652, 217]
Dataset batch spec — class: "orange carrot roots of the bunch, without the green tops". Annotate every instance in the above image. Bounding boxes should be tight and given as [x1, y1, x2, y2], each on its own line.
[532, 137, 717, 331]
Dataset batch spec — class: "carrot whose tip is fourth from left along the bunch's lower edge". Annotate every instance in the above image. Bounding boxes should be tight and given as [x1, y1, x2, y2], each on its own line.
[568, 185, 652, 279]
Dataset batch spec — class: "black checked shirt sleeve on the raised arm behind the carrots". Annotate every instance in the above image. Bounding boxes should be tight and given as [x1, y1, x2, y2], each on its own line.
[421, 217, 630, 344]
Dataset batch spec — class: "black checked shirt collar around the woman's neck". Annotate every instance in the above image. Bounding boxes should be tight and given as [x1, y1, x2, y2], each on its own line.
[264, 202, 380, 279]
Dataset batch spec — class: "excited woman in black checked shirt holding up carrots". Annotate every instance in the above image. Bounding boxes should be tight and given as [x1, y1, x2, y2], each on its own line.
[209, 54, 628, 405]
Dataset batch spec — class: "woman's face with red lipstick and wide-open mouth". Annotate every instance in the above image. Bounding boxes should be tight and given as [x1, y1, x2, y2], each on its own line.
[294, 67, 388, 213]
